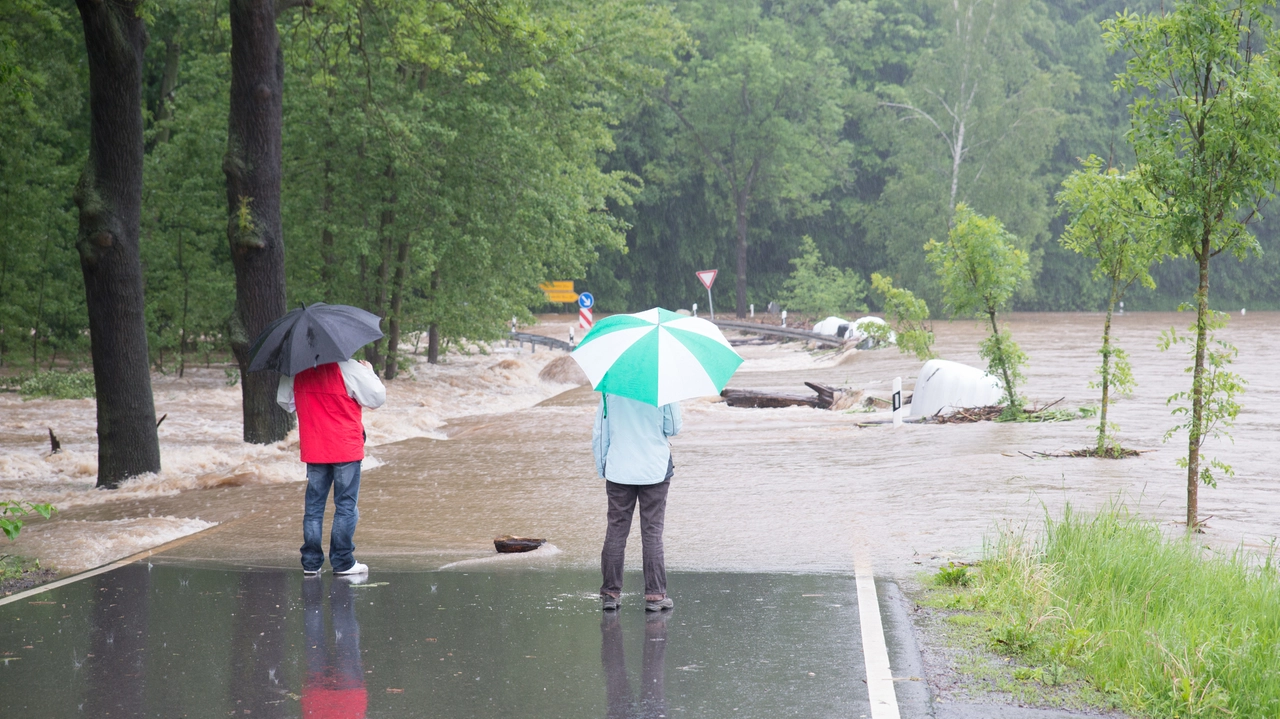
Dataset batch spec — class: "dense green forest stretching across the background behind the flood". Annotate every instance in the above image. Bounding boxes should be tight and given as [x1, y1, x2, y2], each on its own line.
[0, 0, 1280, 377]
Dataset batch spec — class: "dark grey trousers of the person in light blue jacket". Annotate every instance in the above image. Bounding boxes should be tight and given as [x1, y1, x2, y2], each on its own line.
[600, 475, 671, 596]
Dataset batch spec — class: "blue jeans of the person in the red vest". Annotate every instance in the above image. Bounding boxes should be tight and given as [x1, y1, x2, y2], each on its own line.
[302, 462, 360, 572]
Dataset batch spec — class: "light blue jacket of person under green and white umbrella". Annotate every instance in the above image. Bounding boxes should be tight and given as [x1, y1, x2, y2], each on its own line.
[591, 394, 681, 485]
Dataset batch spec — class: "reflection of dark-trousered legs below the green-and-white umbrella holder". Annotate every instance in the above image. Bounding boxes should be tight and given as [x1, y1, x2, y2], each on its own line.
[600, 612, 669, 719]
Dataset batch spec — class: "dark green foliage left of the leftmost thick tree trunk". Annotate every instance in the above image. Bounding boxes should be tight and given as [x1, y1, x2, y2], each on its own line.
[0, 0, 88, 366]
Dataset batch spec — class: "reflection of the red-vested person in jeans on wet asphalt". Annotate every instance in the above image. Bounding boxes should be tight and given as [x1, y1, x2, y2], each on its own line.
[302, 580, 369, 719]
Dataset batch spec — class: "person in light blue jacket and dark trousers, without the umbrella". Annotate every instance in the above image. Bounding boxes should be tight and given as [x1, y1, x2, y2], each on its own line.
[591, 394, 681, 612]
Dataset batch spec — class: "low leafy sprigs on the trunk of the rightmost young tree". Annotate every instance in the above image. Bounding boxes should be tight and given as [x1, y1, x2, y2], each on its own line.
[1160, 312, 1248, 487]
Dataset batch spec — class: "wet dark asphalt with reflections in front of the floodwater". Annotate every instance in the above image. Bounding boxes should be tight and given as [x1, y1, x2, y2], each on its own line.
[0, 564, 869, 719]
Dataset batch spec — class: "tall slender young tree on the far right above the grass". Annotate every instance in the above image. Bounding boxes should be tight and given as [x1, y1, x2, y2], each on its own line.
[1105, 0, 1280, 519]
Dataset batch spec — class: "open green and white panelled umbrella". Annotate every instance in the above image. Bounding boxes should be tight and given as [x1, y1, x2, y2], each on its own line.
[572, 307, 742, 407]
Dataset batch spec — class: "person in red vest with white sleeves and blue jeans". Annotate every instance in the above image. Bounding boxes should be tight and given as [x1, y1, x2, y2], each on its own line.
[275, 360, 387, 577]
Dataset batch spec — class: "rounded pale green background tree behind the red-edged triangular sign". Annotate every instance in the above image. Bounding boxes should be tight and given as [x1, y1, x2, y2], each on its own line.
[653, 0, 851, 315]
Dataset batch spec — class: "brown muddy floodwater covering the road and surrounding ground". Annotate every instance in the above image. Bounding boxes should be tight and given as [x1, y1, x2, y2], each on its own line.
[0, 312, 1280, 576]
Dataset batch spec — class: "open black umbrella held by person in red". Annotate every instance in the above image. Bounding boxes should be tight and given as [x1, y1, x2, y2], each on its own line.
[248, 302, 383, 377]
